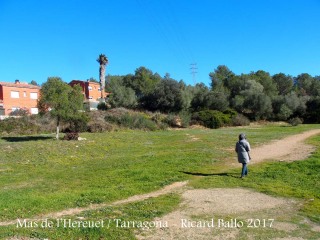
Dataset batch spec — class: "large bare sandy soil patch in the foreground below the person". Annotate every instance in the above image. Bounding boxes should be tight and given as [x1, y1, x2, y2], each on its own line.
[137, 188, 296, 240]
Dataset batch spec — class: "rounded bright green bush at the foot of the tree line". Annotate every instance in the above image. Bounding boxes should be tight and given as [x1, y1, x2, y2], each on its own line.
[192, 110, 231, 128]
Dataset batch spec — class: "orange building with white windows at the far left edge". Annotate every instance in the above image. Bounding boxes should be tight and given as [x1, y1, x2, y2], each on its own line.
[0, 80, 41, 116]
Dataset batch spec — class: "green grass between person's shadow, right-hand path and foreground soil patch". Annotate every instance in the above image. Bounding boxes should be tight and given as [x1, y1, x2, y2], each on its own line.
[191, 136, 320, 223]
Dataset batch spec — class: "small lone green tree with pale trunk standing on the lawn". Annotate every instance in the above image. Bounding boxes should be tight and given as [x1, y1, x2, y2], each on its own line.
[38, 77, 83, 139]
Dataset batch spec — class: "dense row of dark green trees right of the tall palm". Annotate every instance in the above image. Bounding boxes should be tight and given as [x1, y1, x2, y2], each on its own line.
[106, 65, 320, 123]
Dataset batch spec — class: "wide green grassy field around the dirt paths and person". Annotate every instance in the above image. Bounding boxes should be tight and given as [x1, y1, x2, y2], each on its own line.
[0, 125, 320, 239]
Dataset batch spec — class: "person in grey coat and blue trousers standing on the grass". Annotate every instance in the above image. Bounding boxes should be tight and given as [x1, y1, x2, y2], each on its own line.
[235, 133, 251, 178]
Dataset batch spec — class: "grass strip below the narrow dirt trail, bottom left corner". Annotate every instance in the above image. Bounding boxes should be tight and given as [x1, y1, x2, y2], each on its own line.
[0, 194, 180, 240]
